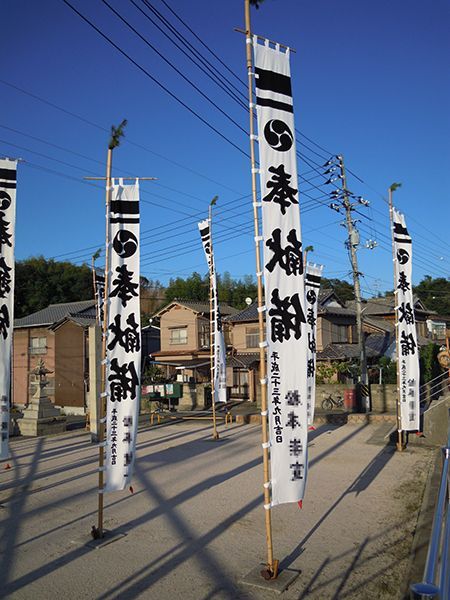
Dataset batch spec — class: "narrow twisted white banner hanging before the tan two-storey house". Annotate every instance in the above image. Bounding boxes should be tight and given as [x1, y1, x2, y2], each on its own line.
[198, 219, 227, 402]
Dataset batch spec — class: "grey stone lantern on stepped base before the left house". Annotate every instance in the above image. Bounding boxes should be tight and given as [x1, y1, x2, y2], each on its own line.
[18, 358, 67, 436]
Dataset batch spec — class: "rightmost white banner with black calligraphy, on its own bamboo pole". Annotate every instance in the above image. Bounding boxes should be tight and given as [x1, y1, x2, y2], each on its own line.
[393, 208, 420, 431]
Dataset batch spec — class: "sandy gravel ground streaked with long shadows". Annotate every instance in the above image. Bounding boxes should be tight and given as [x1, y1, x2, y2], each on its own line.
[0, 422, 433, 600]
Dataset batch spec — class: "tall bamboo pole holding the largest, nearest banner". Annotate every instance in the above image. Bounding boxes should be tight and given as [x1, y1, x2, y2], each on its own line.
[244, 0, 278, 579]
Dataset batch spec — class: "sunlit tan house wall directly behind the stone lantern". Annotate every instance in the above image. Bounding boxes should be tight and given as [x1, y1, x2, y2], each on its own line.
[13, 327, 55, 406]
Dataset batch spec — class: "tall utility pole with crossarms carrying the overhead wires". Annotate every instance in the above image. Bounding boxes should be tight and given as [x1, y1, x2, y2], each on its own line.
[337, 155, 370, 412]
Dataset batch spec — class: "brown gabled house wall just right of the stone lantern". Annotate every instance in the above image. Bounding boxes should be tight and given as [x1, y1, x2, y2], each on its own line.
[55, 321, 86, 408]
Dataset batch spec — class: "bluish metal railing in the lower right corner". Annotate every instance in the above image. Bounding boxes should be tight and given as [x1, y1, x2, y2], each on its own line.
[410, 410, 450, 600]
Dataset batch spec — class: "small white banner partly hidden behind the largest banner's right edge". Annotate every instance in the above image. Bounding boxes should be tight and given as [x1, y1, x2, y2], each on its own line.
[305, 263, 323, 425]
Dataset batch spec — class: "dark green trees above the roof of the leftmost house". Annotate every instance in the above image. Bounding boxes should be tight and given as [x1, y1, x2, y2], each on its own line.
[14, 256, 94, 319]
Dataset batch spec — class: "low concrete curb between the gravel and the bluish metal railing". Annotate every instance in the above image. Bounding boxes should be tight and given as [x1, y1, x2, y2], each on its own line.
[401, 448, 442, 600]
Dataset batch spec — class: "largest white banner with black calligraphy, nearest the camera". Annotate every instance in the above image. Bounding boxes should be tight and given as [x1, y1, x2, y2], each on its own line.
[253, 37, 308, 506]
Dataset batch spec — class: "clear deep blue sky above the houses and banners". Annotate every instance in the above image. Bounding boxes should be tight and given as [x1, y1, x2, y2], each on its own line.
[0, 0, 450, 296]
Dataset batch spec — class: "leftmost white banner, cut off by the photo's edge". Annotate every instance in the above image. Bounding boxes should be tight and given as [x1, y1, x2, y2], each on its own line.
[0, 158, 17, 460]
